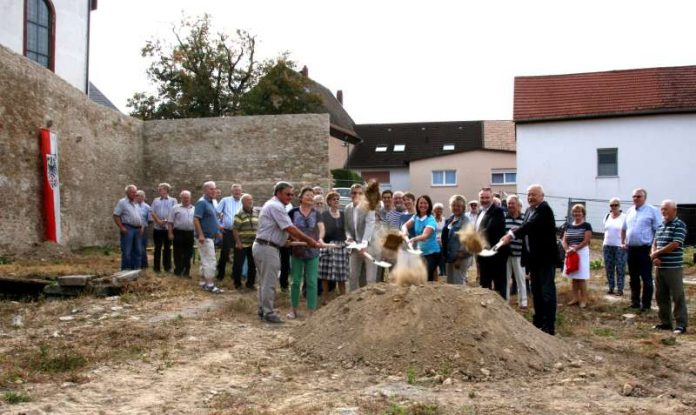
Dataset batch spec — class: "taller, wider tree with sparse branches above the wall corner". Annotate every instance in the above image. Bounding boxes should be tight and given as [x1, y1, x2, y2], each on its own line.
[127, 14, 258, 119]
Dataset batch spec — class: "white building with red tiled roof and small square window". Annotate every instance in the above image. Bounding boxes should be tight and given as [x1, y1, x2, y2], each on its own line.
[514, 66, 696, 240]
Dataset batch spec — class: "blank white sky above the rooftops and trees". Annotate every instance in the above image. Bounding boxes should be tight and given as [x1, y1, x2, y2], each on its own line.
[90, 0, 696, 124]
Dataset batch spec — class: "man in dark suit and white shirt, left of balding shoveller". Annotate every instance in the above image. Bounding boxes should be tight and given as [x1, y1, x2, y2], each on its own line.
[476, 187, 508, 298]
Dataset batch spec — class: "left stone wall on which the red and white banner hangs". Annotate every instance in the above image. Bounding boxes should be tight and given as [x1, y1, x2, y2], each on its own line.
[0, 46, 143, 255]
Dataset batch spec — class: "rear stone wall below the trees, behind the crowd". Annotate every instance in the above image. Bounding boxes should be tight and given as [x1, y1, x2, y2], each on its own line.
[141, 114, 332, 205]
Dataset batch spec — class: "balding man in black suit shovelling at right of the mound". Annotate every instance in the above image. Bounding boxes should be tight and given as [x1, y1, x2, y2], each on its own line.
[500, 184, 558, 336]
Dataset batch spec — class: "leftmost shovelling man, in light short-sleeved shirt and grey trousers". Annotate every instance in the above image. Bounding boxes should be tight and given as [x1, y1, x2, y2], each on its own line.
[251, 182, 322, 323]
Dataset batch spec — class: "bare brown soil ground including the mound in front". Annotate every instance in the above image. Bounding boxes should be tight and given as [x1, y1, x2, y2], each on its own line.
[0, 251, 696, 414]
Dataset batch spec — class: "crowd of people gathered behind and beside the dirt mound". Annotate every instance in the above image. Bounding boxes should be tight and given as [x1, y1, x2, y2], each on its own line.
[114, 182, 686, 334]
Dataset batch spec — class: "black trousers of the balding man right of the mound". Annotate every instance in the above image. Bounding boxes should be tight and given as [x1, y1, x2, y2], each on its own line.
[528, 265, 556, 336]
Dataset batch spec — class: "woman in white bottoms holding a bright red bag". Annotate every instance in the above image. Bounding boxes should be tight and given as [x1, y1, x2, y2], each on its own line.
[561, 204, 592, 308]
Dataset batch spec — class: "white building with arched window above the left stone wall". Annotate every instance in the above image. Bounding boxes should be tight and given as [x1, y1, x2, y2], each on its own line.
[0, 0, 97, 93]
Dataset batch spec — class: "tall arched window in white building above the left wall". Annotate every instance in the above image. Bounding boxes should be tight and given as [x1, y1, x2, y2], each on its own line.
[24, 0, 55, 70]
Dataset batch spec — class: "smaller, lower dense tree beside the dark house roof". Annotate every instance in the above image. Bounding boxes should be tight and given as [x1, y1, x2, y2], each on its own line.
[240, 54, 322, 115]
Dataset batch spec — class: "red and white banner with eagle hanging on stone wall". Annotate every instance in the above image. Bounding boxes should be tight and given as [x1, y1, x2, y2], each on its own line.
[40, 128, 62, 243]
